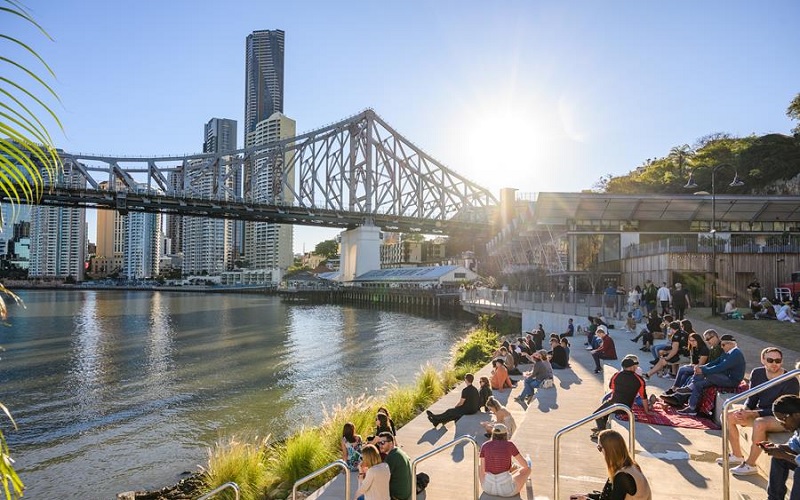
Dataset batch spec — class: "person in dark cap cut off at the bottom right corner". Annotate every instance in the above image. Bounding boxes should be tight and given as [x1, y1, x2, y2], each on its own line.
[758, 394, 800, 500]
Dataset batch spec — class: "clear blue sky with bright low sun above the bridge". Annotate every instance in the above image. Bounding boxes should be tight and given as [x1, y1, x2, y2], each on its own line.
[2, 0, 800, 252]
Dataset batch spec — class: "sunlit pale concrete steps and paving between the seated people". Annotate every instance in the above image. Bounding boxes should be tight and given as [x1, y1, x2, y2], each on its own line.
[310, 308, 800, 500]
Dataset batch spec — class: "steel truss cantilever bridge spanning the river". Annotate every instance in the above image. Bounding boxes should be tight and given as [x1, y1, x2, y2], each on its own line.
[26, 109, 497, 234]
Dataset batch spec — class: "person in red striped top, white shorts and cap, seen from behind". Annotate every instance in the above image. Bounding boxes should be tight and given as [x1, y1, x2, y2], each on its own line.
[478, 424, 531, 497]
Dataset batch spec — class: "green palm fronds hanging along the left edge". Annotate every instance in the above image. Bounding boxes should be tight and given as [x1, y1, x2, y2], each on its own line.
[0, 0, 63, 499]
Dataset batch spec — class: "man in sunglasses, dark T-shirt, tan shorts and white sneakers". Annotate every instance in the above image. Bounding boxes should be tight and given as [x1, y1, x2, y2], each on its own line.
[717, 347, 800, 476]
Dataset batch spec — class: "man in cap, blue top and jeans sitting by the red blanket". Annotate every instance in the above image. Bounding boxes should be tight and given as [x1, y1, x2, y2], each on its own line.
[676, 335, 746, 415]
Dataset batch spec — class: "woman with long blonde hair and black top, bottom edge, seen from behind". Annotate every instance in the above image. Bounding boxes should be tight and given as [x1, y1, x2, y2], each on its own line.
[570, 430, 653, 500]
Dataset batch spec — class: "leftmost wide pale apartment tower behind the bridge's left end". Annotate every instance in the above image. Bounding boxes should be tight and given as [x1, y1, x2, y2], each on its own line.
[28, 164, 87, 281]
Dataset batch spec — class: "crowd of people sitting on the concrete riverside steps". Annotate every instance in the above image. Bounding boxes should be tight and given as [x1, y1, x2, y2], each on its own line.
[341, 292, 800, 500]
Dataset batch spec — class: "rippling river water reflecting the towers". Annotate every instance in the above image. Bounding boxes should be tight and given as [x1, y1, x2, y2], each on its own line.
[0, 291, 468, 499]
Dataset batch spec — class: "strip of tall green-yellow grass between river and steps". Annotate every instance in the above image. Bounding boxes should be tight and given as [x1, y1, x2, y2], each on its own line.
[200, 318, 499, 500]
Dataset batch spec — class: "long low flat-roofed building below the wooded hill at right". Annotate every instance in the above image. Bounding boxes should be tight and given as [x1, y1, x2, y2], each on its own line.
[487, 193, 800, 306]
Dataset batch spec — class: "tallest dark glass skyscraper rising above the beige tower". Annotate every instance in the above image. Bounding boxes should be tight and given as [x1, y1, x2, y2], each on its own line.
[244, 30, 284, 136]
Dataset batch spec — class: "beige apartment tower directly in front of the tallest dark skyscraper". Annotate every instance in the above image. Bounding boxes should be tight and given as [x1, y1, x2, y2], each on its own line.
[245, 113, 297, 270]
